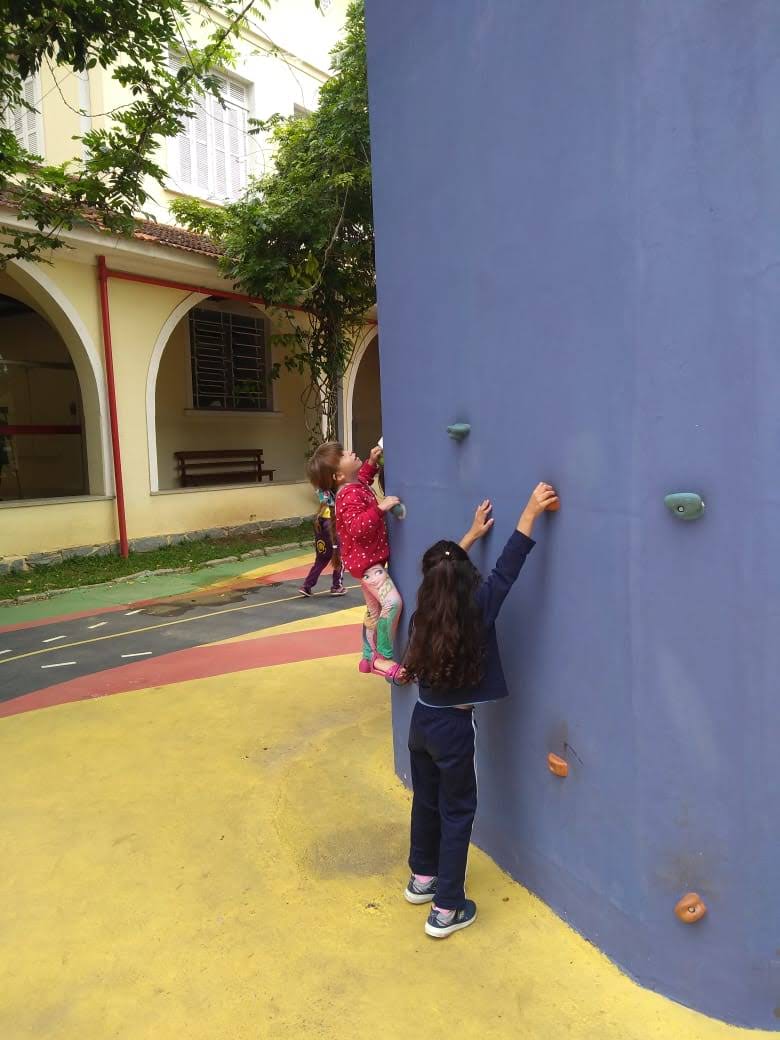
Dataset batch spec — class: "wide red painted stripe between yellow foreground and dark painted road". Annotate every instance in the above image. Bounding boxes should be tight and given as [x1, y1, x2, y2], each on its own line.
[0, 625, 360, 719]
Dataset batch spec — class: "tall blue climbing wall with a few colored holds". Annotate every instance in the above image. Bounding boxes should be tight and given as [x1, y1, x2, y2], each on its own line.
[367, 0, 780, 1029]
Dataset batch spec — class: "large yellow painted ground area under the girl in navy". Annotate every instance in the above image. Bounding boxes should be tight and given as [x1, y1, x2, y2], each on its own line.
[0, 655, 777, 1040]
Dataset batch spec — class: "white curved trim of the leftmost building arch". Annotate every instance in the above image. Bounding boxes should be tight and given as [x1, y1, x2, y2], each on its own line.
[7, 260, 113, 495]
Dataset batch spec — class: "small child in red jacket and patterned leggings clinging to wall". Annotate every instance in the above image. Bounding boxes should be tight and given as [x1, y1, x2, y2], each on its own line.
[312, 441, 402, 679]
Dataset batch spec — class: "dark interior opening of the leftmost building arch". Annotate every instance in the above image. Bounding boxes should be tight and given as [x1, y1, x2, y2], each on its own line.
[0, 275, 89, 501]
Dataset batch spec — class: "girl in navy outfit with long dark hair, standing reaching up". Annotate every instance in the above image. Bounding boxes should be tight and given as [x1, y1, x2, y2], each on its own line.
[397, 484, 558, 938]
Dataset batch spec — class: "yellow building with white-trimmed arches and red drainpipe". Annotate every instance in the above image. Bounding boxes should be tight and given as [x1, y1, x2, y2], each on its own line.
[0, 0, 381, 571]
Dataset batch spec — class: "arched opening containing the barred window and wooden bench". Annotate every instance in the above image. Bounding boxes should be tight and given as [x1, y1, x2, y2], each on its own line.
[147, 293, 306, 493]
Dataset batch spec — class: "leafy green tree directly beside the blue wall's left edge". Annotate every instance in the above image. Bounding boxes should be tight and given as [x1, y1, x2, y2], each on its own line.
[174, 0, 375, 442]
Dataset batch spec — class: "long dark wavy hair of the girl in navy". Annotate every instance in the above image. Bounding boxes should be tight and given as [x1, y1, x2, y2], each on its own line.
[404, 541, 485, 690]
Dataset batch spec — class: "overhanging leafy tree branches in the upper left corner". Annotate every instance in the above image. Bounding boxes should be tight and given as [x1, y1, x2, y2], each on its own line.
[0, 0, 269, 267]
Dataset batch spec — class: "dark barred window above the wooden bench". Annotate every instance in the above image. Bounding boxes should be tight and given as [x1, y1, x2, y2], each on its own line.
[189, 308, 271, 412]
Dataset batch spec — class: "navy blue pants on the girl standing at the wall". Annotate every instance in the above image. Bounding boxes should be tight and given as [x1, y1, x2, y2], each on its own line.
[409, 703, 476, 910]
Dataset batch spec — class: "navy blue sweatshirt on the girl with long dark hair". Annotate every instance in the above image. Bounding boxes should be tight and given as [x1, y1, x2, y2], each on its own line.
[419, 530, 536, 708]
